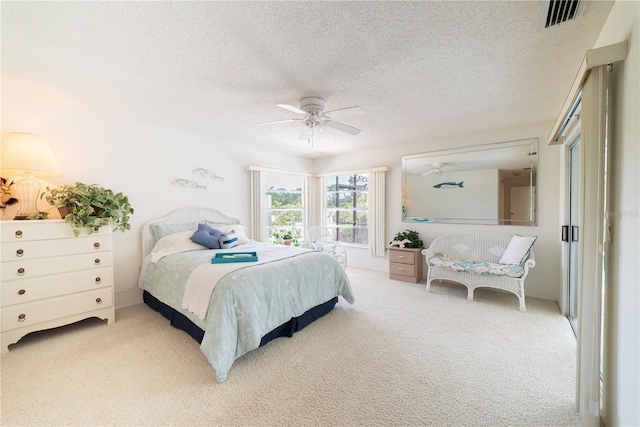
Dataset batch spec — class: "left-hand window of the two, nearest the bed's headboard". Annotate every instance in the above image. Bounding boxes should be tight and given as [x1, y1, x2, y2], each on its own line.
[263, 173, 306, 242]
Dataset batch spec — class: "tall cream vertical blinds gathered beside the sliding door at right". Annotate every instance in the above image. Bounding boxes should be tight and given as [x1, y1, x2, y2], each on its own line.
[576, 65, 609, 426]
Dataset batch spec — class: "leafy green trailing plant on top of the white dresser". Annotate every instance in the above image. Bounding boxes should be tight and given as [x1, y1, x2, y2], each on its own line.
[40, 182, 133, 236]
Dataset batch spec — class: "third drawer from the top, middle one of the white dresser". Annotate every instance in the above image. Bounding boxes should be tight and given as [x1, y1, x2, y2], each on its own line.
[1, 252, 111, 282]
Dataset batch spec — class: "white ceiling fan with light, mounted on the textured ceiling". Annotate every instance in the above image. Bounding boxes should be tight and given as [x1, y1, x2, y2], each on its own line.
[259, 96, 365, 146]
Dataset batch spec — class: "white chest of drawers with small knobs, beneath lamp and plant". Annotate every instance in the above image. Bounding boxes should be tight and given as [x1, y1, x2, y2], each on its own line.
[0, 220, 115, 353]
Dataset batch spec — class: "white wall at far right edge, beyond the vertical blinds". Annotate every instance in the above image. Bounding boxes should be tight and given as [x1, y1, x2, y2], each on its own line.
[594, 0, 640, 426]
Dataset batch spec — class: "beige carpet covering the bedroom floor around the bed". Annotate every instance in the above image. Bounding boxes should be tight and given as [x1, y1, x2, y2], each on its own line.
[1, 268, 577, 426]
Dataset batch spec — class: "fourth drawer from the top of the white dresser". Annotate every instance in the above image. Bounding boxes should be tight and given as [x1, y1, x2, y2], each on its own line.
[1, 267, 113, 307]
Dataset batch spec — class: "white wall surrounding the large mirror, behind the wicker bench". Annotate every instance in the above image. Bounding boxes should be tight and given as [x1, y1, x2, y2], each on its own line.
[314, 122, 561, 301]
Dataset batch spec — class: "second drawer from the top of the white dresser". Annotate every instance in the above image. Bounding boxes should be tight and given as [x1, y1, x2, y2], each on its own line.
[1, 235, 111, 262]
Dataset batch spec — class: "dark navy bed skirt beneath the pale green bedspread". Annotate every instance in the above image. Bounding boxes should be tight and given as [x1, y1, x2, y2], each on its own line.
[142, 291, 338, 347]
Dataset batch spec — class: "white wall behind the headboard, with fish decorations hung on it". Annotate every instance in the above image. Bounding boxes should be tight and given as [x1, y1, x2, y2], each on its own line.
[2, 93, 311, 307]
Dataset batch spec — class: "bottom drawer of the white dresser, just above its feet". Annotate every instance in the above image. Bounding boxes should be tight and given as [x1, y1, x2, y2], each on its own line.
[2, 288, 113, 332]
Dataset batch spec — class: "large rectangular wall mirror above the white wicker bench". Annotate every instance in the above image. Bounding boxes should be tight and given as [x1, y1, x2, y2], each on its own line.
[402, 138, 539, 226]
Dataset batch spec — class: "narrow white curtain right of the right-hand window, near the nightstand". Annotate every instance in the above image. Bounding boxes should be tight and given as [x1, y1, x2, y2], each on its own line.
[368, 171, 386, 257]
